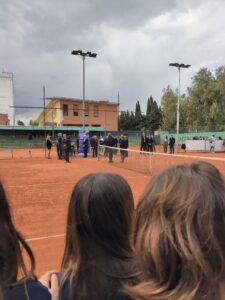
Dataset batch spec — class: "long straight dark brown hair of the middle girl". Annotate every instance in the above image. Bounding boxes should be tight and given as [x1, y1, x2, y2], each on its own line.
[61, 173, 137, 300]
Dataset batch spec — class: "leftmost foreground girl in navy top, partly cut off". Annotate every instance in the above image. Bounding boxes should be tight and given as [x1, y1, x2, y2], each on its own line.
[0, 182, 51, 300]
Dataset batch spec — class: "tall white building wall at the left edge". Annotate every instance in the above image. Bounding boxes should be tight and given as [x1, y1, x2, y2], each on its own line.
[0, 72, 15, 125]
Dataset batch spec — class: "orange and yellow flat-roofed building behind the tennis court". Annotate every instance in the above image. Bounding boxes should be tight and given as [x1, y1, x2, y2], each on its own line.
[36, 97, 119, 131]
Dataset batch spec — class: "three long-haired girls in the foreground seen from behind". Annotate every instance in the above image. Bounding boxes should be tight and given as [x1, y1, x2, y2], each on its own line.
[0, 161, 225, 300]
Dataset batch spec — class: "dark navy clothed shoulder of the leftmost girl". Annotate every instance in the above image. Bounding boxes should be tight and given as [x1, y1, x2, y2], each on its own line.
[4, 279, 51, 300]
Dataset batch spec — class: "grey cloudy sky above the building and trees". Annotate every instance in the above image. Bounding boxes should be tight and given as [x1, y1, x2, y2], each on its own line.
[0, 0, 225, 119]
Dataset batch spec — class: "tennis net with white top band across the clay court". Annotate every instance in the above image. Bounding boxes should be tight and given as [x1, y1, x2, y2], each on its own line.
[98, 145, 225, 176]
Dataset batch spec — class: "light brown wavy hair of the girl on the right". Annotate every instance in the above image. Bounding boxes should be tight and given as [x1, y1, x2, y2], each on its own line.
[126, 162, 225, 300]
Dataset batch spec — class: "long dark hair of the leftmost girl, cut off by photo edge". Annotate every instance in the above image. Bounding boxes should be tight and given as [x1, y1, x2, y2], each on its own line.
[0, 182, 36, 295]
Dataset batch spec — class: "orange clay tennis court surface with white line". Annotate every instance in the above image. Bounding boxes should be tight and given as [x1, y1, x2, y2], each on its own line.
[0, 149, 225, 275]
